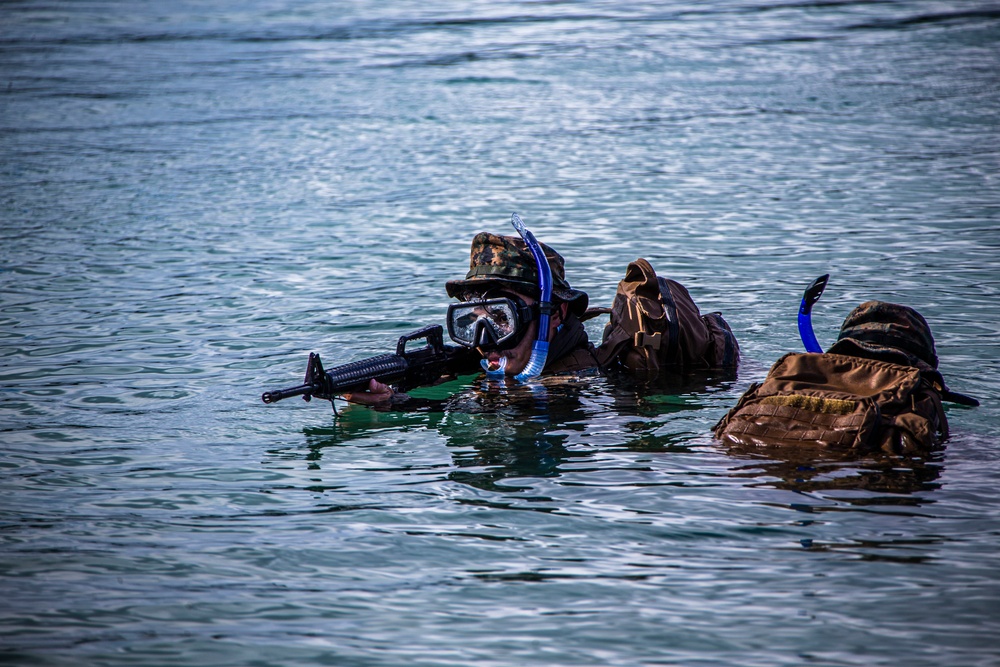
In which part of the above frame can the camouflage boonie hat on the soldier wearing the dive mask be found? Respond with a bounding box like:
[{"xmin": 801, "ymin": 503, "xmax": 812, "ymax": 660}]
[{"xmin": 445, "ymin": 232, "xmax": 589, "ymax": 315}]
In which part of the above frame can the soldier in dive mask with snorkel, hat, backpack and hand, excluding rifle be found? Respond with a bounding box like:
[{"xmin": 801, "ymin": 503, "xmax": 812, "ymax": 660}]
[{"xmin": 343, "ymin": 214, "xmax": 739, "ymax": 409}]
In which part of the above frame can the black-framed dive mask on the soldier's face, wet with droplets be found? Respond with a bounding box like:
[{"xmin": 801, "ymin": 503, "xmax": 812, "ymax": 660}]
[{"xmin": 448, "ymin": 295, "xmax": 537, "ymax": 350}]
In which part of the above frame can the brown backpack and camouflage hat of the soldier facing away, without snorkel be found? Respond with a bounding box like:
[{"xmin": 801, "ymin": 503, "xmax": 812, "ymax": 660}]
[{"xmin": 715, "ymin": 301, "xmax": 979, "ymax": 454}]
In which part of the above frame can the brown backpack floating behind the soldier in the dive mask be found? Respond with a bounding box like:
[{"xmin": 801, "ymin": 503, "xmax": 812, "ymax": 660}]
[{"xmin": 596, "ymin": 259, "xmax": 740, "ymax": 380}]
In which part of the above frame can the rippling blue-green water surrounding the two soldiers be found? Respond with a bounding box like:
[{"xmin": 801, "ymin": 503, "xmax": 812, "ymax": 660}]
[{"xmin": 0, "ymin": 0, "xmax": 1000, "ymax": 666}]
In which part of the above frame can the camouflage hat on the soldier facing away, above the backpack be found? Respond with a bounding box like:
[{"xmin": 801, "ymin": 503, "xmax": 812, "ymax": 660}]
[{"xmin": 829, "ymin": 301, "xmax": 938, "ymax": 369}]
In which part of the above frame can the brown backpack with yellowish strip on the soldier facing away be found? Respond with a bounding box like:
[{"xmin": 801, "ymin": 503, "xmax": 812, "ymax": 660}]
[{"xmin": 715, "ymin": 353, "xmax": 948, "ymax": 454}]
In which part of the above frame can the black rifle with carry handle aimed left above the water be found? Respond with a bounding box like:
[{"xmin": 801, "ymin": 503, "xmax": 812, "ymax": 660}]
[{"xmin": 261, "ymin": 324, "xmax": 479, "ymax": 403}]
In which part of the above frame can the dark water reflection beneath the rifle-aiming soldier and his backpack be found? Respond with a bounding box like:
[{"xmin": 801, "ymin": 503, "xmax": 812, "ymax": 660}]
[{"xmin": 296, "ymin": 374, "xmax": 735, "ymax": 492}]
